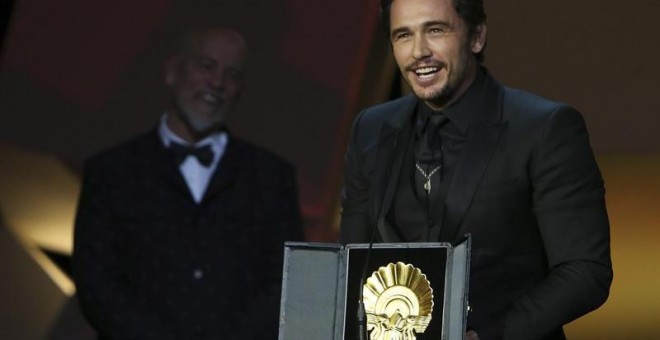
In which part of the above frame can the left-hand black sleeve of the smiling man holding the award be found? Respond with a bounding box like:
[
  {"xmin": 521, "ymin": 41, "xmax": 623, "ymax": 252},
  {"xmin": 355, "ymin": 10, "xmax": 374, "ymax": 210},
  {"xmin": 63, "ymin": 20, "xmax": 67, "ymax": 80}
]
[{"xmin": 339, "ymin": 111, "xmax": 371, "ymax": 244}]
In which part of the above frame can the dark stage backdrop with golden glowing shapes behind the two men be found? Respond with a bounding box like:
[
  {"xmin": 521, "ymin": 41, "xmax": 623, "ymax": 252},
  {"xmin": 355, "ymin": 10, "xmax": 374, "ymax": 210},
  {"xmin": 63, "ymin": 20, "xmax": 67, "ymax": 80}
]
[{"xmin": 0, "ymin": 0, "xmax": 660, "ymax": 339}]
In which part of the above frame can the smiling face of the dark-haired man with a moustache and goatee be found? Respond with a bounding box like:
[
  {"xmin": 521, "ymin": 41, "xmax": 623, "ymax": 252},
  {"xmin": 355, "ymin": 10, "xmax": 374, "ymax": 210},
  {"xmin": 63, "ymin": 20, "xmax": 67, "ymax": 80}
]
[{"xmin": 390, "ymin": 0, "xmax": 486, "ymax": 109}]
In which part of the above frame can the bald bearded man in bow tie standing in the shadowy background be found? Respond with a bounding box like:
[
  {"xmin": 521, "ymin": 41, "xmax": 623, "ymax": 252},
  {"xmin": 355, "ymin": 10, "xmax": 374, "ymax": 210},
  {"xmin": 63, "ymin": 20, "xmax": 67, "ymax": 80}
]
[{"xmin": 73, "ymin": 29, "xmax": 302, "ymax": 339}]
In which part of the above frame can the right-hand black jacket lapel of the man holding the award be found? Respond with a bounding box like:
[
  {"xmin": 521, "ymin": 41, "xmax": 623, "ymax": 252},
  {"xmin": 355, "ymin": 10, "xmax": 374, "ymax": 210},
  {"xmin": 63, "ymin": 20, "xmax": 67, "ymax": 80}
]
[{"xmin": 436, "ymin": 75, "xmax": 506, "ymax": 242}]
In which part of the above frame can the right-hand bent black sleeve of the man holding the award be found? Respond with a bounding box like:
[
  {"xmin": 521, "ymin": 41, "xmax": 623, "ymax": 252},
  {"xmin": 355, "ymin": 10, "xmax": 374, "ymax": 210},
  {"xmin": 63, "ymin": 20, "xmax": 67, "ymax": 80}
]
[{"xmin": 504, "ymin": 107, "xmax": 612, "ymax": 339}]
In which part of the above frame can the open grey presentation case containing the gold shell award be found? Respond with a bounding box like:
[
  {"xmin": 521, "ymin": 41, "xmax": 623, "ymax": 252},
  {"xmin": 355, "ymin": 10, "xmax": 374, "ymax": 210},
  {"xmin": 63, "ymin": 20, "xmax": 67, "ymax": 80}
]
[{"xmin": 279, "ymin": 236, "xmax": 470, "ymax": 340}]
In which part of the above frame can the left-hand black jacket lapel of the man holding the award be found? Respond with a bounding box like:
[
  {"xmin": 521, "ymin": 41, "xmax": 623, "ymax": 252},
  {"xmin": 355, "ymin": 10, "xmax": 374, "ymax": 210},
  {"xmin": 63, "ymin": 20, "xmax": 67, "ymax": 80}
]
[{"xmin": 373, "ymin": 96, "xmax": 417, "ymax": 242}]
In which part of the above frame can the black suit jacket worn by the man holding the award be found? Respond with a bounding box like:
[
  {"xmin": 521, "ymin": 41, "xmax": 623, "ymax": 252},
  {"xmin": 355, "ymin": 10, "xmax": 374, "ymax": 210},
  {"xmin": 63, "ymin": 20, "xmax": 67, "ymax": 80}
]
[{"xmin": 340, "ymin": 76, "xmax": 612, "ymax": 340}]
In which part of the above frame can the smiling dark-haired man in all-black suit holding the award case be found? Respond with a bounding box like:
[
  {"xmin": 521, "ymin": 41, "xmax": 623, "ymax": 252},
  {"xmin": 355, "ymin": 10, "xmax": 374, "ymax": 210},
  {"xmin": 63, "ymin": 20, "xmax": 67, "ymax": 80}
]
[{"xmin": 340, "ymin": 0, "xmax": 612, "ymax": 339}]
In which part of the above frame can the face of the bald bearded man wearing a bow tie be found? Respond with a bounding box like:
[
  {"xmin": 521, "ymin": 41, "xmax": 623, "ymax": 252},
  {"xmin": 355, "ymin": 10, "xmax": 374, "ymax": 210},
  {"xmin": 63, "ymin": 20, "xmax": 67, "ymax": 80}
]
[{"xmin": 165, "ymin": 30, "xmax": 245, "ymax": 135}]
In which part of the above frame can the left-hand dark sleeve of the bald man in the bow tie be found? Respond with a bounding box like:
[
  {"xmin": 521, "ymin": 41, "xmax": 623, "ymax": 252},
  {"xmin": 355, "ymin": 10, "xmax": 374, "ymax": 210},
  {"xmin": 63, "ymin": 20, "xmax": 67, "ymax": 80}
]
[{"xmin": 72, "ymin": 163, "xmax": 175, "ymax": 339}]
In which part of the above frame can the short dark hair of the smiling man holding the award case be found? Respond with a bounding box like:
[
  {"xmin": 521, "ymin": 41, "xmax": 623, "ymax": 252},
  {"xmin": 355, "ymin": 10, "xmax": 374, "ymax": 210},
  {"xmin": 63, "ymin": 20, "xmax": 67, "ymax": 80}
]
[{"xmin": 380, "ymin": 0, "xmax": 486, "ymax": 63}]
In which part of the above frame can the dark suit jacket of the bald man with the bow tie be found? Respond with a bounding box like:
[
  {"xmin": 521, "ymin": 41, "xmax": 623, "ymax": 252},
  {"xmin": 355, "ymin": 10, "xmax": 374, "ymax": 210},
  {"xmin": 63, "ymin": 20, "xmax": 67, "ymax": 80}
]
[{"xmin": 73, "ymin": 131, "xmax": 302, "ymax": 339}]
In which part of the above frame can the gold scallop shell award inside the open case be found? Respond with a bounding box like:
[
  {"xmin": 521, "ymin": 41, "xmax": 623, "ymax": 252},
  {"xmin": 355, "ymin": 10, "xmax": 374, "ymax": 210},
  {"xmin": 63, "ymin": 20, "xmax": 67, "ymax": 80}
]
[{"xmin": 362, "ymin": 262, "xmax": 433, "ymax": 340}]
